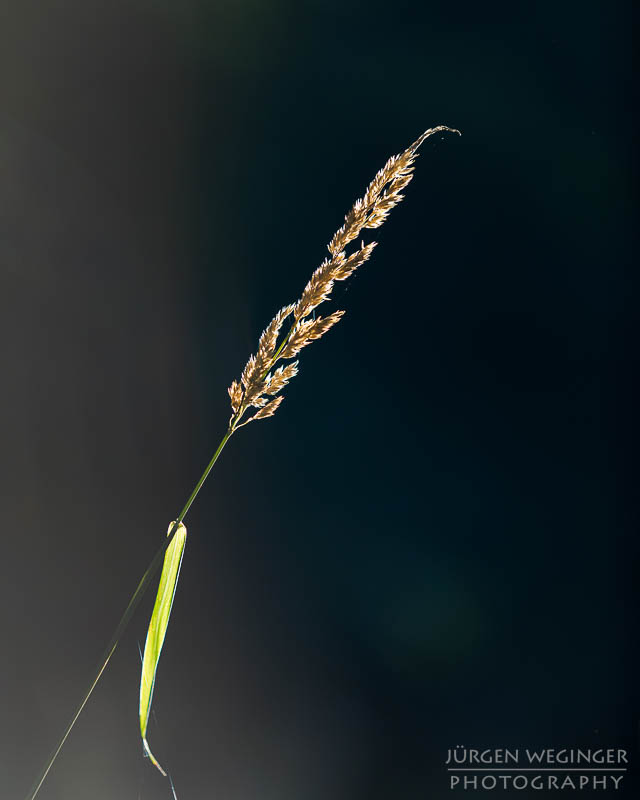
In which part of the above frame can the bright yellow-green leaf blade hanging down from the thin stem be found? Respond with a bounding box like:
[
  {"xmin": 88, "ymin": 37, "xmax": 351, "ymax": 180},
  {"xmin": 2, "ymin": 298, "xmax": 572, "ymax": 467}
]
[{"xmin": 140, "ymin": 522, "xmax": 187, "ymax": 775}]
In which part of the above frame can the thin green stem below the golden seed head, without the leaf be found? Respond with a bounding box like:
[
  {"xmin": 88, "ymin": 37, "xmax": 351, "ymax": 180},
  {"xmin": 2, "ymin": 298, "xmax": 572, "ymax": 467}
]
[{"xmin": 26, "ymin": 421, "xmax": 235, "ymax": 800}]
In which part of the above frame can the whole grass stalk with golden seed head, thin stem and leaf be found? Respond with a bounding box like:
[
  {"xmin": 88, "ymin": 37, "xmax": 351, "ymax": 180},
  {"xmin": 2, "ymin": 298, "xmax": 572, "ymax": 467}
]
[{"xmin": 26, "ymin": 125, "xmax": 459, "ymax": 800}]
